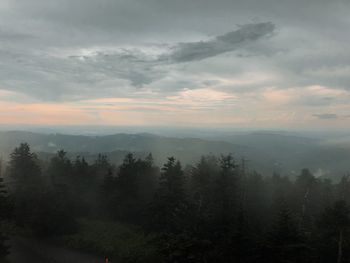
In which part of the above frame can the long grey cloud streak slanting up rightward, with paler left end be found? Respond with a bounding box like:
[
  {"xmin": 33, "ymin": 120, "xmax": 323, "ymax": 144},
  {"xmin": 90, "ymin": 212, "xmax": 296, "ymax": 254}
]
[{"xmin": 62, "ymin": 22, "xmax": 275, "ymax": 91}]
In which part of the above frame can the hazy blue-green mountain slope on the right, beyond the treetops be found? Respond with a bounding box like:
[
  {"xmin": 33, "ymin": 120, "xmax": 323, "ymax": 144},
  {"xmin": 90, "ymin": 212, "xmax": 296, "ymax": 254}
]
[{"xmin": 222, "ymin": 132, "xmax": 350, "ymax": 177}]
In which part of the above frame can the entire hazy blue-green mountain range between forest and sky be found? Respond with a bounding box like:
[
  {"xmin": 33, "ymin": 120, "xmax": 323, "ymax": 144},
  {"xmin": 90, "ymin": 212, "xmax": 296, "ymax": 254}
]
[{"xmin": 0, "ymin": 131, "xmax": 350, "ymax": 177}]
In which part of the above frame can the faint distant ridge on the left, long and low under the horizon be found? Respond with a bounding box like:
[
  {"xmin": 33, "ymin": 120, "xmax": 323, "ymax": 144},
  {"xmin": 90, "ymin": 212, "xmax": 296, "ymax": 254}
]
[{"xmin": 0, "ymin": 131, "xmax": 243, "ymax": 153}]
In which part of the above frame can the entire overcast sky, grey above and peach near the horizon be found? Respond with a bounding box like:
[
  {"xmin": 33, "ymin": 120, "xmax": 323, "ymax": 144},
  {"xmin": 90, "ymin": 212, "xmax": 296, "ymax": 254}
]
[{"xmin": 0, "ymin": 0, "xmax": 350, "ymax": 129}]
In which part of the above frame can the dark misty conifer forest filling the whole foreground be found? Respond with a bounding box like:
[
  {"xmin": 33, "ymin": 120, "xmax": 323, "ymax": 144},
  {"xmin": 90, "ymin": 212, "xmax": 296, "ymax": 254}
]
[{"xmin": 0, "ymin": 143, "xmax": 350, "ymax": 263}]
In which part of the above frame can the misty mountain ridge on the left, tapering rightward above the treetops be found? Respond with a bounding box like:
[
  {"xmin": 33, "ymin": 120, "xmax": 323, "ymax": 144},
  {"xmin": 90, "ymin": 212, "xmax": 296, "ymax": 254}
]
[{"xmin": 0, "ymin": 131, "xmax": 244, "ymax": 166}]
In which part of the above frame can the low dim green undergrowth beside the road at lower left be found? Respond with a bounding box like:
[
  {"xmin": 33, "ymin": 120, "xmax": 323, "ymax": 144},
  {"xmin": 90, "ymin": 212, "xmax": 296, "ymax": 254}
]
[{"xmin": 64, "ymin": 219, "xmax": 161, "ymax": 263}]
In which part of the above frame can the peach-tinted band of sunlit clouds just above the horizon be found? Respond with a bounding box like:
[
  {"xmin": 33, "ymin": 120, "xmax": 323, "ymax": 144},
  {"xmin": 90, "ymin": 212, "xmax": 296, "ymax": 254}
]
[{"xmin": 0, "ymin": 86, "xmax": 350, "ymax": 127}]
